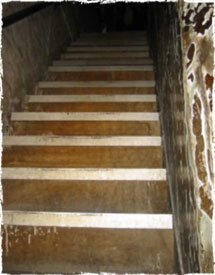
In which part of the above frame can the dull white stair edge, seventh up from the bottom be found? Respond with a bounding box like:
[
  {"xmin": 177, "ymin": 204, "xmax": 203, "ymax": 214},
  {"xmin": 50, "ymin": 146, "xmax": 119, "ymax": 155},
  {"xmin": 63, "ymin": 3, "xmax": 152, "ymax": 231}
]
[{"xmin": 48, "ymin": 65, "xmax": 154, "ymax": 72}]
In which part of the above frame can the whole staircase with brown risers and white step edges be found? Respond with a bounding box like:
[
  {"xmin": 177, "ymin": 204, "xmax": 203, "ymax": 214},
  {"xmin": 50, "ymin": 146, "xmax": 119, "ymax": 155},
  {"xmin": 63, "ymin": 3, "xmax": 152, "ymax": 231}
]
[{"xmin": 2, "ymin": 32, "xmax": 175, "ymax": 274}]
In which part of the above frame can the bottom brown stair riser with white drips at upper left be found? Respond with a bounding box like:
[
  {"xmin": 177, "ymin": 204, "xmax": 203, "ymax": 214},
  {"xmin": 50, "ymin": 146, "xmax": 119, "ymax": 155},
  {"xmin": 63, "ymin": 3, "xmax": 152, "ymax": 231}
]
[{"xmin": 2, "ymin": 226, "xmax": 174, "ymax": 274}]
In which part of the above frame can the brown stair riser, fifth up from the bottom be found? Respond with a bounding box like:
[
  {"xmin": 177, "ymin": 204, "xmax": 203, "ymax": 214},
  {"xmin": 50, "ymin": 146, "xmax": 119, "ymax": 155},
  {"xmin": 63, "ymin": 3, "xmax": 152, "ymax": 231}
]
[{"xmin": 26, "ymin": 102, "xmax": 157, "ymax": 112}]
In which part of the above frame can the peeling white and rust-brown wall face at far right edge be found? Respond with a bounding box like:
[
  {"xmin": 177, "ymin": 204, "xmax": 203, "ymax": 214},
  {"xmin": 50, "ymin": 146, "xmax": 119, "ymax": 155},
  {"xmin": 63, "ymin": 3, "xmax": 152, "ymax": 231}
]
[{"xmin": 180, "ymin": 3, "xmax": 214, "ymax": 271}]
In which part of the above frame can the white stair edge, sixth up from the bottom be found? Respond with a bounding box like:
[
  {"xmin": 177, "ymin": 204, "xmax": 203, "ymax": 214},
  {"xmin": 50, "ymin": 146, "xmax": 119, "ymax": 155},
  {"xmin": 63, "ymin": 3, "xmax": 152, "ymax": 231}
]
[{"xmin": 38, "ymin": 80, "xmax": 155, "ymax": 88}]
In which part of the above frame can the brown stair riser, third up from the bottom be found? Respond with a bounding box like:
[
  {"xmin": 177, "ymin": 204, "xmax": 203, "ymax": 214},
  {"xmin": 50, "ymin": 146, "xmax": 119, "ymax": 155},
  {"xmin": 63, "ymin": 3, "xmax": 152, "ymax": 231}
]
[{"xmin": 2, "ymin": 146, "xmax": 162, "ymax": 168}]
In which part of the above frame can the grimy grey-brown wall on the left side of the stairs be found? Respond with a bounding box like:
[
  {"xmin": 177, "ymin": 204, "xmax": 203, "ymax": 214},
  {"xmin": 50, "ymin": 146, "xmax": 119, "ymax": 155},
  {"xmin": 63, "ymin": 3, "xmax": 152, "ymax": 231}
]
[{"xmin": 2, "ymin": 3, "xmax": 77, "ymax": 133}]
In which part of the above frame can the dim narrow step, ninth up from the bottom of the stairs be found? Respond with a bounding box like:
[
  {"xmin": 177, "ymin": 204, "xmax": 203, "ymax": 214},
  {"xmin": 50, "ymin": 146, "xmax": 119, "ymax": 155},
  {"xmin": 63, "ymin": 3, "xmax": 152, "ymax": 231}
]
[{"xmin": 61, "ymin": 51, "xmax": 149, "ymax": 59}]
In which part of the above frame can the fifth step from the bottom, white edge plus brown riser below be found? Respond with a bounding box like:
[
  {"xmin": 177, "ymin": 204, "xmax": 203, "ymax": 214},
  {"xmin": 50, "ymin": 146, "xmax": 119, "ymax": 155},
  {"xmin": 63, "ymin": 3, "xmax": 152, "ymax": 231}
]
[{"xmin": 26, "ymin": 94, "xmax": 157, "ymax": 112}]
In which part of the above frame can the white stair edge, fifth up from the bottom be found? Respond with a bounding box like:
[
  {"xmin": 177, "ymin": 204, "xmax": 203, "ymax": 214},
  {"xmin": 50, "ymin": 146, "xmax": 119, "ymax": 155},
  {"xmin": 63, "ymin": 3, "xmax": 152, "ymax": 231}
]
[{"xmin": 26, "ymin": 94, "xmax": 156, "ymax": 103}]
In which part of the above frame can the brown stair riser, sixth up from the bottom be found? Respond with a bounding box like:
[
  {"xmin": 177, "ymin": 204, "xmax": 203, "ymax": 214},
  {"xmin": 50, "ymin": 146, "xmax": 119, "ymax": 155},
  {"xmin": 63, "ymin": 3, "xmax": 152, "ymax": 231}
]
[{"xmin": 37, "ymin": 87, "xmax": 155, "ymax": 95}]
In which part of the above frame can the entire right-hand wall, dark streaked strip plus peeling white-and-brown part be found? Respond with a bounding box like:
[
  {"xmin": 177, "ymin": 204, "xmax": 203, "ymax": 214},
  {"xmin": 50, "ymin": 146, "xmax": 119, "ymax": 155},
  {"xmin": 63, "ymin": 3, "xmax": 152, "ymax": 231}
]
[{"xmin": 150, "ymin": 3, "xmax": 214, "ymax": 273}]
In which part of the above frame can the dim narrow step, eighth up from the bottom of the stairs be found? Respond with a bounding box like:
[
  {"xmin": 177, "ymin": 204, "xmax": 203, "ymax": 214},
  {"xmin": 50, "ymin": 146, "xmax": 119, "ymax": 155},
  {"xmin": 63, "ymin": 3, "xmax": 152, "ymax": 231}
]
[{"xmin": 53, "ymin": 57, "xmax": 153, "ymax": 66}]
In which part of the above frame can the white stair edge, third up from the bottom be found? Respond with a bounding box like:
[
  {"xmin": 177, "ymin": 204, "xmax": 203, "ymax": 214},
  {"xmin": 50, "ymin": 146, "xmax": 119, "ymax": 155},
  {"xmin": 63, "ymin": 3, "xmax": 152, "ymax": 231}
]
[{"xmin": 3, "ymin": 136, "xmax": 161, "ymax": 146}]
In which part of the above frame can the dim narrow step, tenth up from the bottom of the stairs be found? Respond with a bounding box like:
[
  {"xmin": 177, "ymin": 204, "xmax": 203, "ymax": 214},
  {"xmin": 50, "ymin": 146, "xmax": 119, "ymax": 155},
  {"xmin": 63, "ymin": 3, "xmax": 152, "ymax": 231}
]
[{"xmin": 67, "ymin": 45, "xmax": 149, "ymax": 52}]
